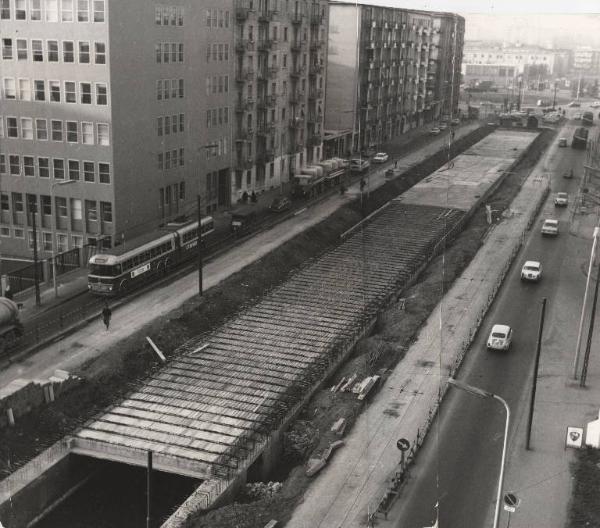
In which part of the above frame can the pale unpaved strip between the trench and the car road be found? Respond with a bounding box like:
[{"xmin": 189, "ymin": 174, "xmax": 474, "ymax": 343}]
[{"xmin": 286, "ymin": 144, "xmax": 547, "ymax": 528}]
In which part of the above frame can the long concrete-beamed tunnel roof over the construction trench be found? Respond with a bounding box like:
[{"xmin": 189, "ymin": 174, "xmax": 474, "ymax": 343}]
[{"xmin": 0, "ymin": 131, "xmax": 536, "ymax": 527}]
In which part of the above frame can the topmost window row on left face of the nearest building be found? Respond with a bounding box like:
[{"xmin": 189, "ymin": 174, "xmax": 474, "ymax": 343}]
[{"xmin": 0, "ymin": 0, "xmax": 106, "ymax": 22}]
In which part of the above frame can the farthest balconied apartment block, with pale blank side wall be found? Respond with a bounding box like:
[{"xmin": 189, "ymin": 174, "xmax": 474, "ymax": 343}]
[{"xmin": 325, "ymin": 2, "xmax": 464, "ymax": 155}]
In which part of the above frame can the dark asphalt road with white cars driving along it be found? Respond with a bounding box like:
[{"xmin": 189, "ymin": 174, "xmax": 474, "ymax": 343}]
[{"xmin": 394, "ymin": 120, "xmax": 585, "ymax": 528}]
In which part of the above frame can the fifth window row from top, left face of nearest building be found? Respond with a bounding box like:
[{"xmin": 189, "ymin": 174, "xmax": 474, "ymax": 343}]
[{"xmin": 0, "ymin": 154, "xmax": 111, "ymax": 184}]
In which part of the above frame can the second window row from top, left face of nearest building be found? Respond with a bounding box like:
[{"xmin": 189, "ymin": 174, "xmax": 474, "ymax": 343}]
[{"xmin": 2, "ymin": 38, "xmax": 106, "ymax": 64}]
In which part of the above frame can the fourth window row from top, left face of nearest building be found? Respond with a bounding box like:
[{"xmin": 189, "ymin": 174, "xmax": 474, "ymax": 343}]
[{"xmin": 0, "ymin": 117, "xmax": 110, "ymax": 146}]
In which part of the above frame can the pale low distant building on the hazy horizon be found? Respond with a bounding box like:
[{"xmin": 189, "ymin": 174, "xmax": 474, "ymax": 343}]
[{"xmin": 462, "ymin": 41, "xmax": 564, "ymax": 88}]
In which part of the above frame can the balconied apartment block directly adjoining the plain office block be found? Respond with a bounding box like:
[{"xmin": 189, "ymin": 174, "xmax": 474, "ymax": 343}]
[{"xmin": 232, "ymin": 0, "xmax": 328, "ymax": 199}]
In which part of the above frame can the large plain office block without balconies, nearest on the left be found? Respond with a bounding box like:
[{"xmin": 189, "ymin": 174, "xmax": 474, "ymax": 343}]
[{"xmin": 0, "ymin": 0, "xmax": 234, "ymax": 258}]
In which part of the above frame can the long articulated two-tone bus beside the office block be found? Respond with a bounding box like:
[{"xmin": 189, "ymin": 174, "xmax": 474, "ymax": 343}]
[{"xmin": 88, "ymin": 216, "xmax": 215, "ymax": 297}]
